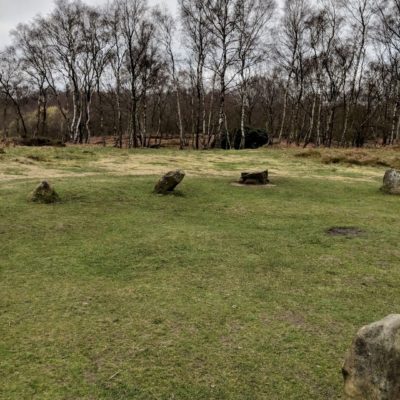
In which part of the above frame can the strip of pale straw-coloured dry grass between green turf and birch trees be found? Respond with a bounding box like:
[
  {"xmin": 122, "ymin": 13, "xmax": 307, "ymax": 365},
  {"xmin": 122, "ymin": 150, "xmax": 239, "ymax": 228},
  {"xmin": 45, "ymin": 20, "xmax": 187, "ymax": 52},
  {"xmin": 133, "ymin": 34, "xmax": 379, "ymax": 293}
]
[{"xmin": 0, "ymin": 146, "xmax": 400, "ymax": 186}]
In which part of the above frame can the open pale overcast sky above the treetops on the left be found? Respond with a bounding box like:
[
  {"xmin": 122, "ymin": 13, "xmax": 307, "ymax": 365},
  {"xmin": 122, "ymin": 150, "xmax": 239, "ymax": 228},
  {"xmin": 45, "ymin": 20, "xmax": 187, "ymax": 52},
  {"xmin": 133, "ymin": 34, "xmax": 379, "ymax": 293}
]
[{"xmin": 0, "ymin": 0, "xmax": 177, "ymax": 47}]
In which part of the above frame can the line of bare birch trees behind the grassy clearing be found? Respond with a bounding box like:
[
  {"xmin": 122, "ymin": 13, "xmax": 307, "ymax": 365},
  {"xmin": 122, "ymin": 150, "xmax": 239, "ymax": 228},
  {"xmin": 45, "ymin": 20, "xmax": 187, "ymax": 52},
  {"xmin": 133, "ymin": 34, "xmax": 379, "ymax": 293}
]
[{"xmin": 0, "ymin": 0, "xmax": 400, "ymax": 149}]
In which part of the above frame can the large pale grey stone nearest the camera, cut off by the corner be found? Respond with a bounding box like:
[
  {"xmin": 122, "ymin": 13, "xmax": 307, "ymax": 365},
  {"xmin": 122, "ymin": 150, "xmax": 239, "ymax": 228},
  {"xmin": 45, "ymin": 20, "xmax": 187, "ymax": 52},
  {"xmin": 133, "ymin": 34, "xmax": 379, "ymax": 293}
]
[{"xmin": 342, "ymin": 314, "xmax": 400, "ymax": 400}]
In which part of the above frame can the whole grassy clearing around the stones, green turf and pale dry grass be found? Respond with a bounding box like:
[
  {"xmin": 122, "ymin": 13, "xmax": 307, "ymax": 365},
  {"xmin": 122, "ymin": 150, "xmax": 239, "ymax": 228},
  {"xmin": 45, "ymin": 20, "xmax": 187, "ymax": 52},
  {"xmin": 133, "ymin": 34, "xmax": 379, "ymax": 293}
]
[{"xmin": 0, "ymin": 147, "xmax": 400, "ymax": 400}]
